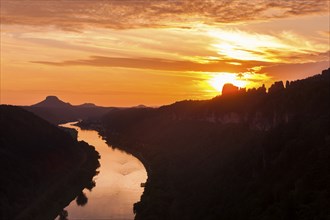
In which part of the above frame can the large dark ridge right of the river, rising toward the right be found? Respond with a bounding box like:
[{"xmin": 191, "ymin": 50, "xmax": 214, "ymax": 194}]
[{"xmin": 81, "ymin": 69, "xmax": 330, "ymax": 220}]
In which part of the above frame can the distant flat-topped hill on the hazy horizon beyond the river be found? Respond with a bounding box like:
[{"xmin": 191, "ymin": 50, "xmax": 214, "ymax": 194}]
[{"xmin": 23, "ymin": 96, "xmax": 115, "ymax": 124}]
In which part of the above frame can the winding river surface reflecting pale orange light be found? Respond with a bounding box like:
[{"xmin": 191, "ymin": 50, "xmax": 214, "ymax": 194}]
[{"xmin": 61, "ymin": 123, "xmax": 147, "ymax": 220}]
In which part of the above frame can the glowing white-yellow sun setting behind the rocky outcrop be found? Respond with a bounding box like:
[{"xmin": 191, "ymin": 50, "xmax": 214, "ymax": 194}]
[{"xmin": 208, "ymin": 73, "xmax": 248, "ymax": 92}]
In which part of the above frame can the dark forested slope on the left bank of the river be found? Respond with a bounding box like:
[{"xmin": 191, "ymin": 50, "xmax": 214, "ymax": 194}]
[{"xmin": 0, "ymin": 105, "xmax": 99, "ymax": 220}]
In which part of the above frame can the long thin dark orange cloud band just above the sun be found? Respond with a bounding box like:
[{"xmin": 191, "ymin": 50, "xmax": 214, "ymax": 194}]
[{"xmin": 31, "ymin": 56, "xmax": 329, "ymax": 82}]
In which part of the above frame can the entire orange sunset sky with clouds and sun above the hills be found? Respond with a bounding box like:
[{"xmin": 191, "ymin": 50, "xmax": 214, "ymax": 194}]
[{"xmin": 1, "ymin": 0, "xmax": 330, "ymax": 106}]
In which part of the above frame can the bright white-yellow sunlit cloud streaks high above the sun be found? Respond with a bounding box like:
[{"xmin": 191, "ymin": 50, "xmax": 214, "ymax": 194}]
[{"xmin": 209, "ymin": 29, "xmax": 329, "ymax": 63}]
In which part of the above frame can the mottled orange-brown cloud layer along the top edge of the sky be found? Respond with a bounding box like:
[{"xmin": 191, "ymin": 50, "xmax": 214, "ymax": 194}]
[{"xmin": 1, "ymin": 0, "xmax": 329, "ymax": 30}]
